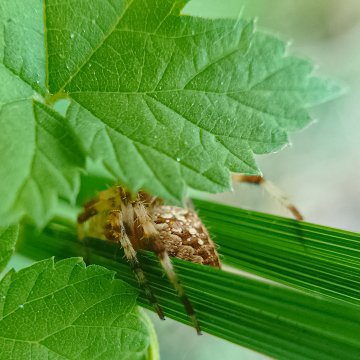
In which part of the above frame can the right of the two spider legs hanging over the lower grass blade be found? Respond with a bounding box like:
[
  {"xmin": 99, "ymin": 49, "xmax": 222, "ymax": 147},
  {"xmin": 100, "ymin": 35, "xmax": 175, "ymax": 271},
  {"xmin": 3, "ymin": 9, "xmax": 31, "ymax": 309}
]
[{"xmin": 134, "ymin": 202, "xmax": 202, "ymax": 335}]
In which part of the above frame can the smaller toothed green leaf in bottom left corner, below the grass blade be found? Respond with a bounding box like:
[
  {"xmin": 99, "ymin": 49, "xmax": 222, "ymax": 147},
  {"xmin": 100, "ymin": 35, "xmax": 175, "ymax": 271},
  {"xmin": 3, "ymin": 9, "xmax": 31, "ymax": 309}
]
[{"xmin": 0, "ymin": 258, "xmax": 158, "ymax": 360}]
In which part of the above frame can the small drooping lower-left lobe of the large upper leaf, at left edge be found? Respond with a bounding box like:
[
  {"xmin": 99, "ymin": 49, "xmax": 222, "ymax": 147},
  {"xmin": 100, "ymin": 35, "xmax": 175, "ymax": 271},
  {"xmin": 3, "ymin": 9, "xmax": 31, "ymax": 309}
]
[{"xmin": 0, "ymin": 87, "xmax": 84, "ymax": 226}]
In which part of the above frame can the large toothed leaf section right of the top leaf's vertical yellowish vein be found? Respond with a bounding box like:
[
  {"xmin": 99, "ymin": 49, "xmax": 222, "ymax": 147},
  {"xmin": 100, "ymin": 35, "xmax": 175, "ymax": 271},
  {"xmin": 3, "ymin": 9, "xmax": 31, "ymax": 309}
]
[{"xmin": 45, "ymin": 0, "xmax": 339, "ymax": 201}]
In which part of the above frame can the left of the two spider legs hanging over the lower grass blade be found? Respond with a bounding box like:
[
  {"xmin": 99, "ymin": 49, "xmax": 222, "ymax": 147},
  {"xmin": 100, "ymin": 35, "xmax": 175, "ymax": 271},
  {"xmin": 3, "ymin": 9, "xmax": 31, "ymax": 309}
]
[{"xmin": 105, "ymin": 210, "xmax": 165, "ymax": 320}]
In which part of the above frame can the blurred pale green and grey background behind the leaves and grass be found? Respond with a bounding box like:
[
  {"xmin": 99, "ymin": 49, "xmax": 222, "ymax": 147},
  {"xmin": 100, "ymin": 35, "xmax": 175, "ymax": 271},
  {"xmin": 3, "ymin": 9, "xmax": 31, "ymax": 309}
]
[{"xmin": 3, "ymin": 0, "xmax": 360, "ymax": 360}]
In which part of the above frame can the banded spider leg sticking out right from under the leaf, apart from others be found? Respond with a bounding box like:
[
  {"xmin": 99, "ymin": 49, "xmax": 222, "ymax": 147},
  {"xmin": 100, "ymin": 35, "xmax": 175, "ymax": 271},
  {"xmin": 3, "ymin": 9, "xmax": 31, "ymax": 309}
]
[{"xmin": 232, "ymin": 174, "xmax": 304, "ymax": 220}]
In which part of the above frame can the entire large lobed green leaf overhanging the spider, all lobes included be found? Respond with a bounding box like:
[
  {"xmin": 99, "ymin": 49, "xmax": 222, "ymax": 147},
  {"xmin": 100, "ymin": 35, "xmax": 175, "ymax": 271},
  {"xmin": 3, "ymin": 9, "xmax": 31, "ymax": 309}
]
[{"xmin": 0, "ymin": 0, "xmax": 338, "ymax": 226}]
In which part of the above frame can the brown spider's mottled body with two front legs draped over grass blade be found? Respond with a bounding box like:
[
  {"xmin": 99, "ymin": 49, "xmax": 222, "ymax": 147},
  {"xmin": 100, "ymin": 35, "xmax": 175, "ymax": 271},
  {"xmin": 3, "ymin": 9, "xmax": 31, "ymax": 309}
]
[{"xmin": 78, "ymin": 186, "xmax": 221, "ymax": 334}]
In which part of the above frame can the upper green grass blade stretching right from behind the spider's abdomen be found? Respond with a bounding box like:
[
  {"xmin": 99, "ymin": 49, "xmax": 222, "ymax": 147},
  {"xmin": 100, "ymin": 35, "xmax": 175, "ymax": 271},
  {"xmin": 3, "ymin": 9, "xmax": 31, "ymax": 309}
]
[{"xmin": 194, "ymin": 200, "xmax": 360, "ymax": 305}]
